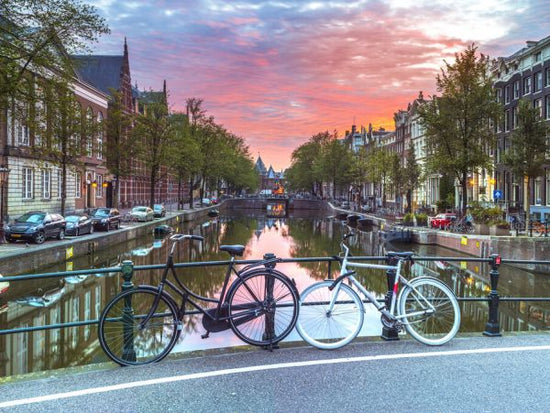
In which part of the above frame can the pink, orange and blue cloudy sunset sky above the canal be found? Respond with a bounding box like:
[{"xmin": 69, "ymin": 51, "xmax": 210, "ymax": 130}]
[{"xmin": 88, "ymin": 0, "xmax": 550, "ymax": 171}]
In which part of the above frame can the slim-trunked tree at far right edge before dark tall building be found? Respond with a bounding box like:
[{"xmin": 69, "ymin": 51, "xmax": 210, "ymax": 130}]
[{"xmin": 503, "ymin": 99, "xmax": 550, "ymax": 228}]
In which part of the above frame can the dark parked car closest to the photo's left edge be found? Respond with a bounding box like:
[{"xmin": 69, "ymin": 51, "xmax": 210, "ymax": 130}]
[{"xmin": 4, "ymin": 211, "xmax": 65, "ymax": 244}]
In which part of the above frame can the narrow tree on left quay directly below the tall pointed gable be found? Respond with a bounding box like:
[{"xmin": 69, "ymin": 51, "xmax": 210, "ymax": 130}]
[{"xmin": 105, "ymin": 90, "xmax": 137, "ymax": 207}]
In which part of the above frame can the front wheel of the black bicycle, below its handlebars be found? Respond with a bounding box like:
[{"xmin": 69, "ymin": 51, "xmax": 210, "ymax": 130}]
[{"xmin": 98, "ymin": 287, "xmax": 181, "ymax": 366}]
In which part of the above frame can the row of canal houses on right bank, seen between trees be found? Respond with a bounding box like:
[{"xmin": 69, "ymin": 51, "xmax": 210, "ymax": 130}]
[{"xmin": 342, "ymin": 36, "xmax": 550, "ymax": 212}]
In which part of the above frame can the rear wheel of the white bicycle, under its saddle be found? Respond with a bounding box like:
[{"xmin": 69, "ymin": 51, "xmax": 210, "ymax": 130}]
[{"xmin": 397, "ymin": 277, "xmax": 460, "ymax": 346}]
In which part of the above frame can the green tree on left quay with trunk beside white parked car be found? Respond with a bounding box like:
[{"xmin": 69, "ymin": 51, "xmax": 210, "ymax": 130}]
[{"xmin": 132, "ymin": 91, "xmax": 175, "ymax": 208}]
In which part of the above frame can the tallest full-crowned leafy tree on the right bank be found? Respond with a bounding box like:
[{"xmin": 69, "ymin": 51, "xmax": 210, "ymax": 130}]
[{"xmin": 418, "ymin": 45, "xmax": 500, "ymax": 213}]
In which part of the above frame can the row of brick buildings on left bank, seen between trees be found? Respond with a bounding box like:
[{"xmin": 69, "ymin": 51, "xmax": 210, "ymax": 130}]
[{"xmin": 0, "ymin": 40, "xmax": 181, "ymax": 222}]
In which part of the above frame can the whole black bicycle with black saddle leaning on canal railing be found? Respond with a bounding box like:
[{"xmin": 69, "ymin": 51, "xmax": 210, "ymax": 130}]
[{"xmin": 98, "ymin": 234, "xmax": 299, "ymax": 366}]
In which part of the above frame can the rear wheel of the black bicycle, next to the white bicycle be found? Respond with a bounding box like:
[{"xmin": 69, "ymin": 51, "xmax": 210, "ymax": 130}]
[{"xmin": 227, "ymin": 271, "xmax": 299, "ymax": 346}]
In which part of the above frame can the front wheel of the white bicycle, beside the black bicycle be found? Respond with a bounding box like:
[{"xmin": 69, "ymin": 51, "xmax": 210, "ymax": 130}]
[{"xmin": 296, "ymin": 281, "xmax": 364, "ymax": 350}]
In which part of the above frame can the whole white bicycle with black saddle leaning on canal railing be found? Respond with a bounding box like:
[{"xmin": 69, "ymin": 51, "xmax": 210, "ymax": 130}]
[{"xmin": 296, "ymin": 233, "xmax": 460, "ymax": 350}]
